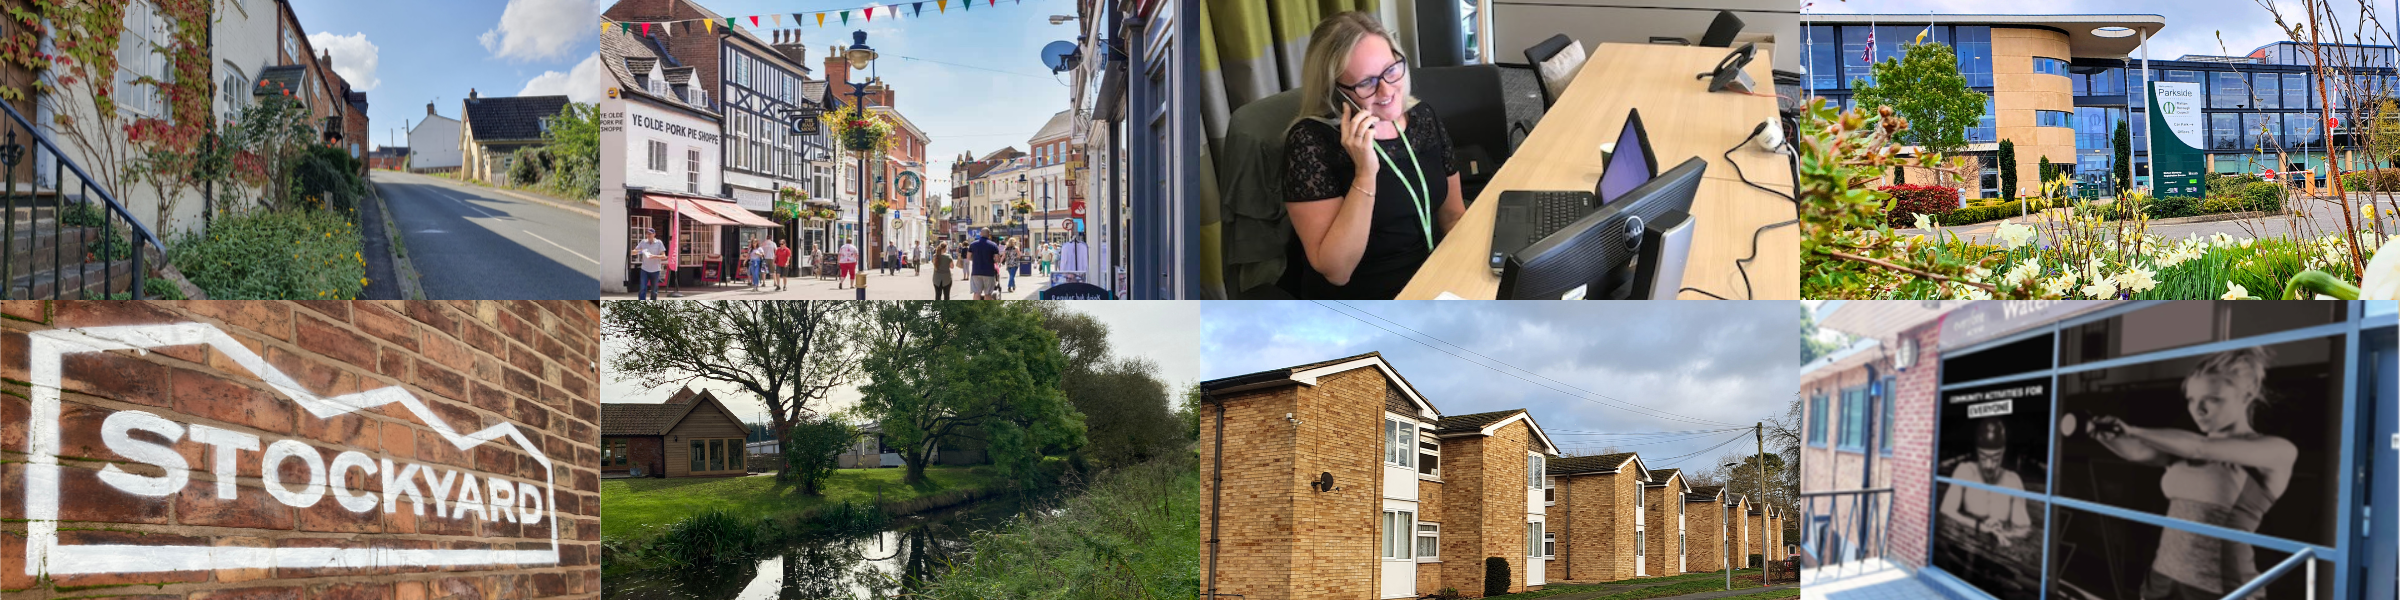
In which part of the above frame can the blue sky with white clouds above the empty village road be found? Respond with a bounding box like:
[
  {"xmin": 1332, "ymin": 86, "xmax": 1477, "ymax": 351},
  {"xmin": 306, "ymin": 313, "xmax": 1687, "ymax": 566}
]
[{"xmin": 293, "ymin": 0, "xmax": 605, "ymax": 146}]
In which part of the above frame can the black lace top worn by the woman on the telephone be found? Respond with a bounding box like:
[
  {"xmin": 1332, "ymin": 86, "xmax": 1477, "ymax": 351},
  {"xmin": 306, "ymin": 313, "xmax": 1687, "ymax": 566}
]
[{"xmin": 1284, "ymin": 103, "xmax": 1457, "ymax": 300}]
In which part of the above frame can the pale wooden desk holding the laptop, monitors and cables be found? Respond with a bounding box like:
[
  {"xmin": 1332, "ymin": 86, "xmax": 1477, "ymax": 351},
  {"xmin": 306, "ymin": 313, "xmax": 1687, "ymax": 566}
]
[{"xmin": 1399, "ymin": 43, "xmax": 1800, "ymax": 300}]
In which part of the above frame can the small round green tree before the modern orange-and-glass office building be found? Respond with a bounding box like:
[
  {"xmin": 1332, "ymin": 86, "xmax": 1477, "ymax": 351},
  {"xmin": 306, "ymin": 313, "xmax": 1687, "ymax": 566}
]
[{"xmin": 1850, "ymin": 43, "xmax": 1985, "ymax": 185}]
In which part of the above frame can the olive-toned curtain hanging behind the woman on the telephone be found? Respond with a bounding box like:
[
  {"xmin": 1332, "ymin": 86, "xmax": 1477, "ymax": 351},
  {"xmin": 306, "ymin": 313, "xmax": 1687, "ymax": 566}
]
[{"xmin": 1200, "ymin": 0, "xmax": 1399, "ymax": 298}]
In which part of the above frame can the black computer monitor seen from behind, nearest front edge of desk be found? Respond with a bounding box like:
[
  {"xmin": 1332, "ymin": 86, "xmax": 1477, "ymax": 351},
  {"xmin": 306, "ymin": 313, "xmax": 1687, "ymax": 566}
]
[{"xmin": 1498, "ymin": 156, "xmax": 1709, "ymax": 300}]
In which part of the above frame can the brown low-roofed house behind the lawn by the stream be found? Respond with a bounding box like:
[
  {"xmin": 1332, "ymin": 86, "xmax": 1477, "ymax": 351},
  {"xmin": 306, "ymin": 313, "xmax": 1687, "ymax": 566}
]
[{"xmin": 600, "ymin": 386, "xmax": 749, "ymax": 478}]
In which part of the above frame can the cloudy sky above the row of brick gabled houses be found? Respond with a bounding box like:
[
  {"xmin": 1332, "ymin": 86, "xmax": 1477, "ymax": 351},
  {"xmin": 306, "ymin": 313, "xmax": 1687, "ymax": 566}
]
[{"xmin": 1200, "ymin": 302, "xmax": 1800, "ymax": 470}]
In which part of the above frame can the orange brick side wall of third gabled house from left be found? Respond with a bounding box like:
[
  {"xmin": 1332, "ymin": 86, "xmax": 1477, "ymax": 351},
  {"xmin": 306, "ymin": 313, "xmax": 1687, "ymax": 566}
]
[{"xmin": 1553, "ymin": 473, "xmax": 1639, "ymax": 581}]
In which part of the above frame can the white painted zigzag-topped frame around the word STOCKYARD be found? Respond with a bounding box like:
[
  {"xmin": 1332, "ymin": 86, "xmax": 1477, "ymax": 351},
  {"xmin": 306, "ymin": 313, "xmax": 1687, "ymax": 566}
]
[{"xmin": 24, "ymin": 324, "xmax": 559, "ymax": 576}]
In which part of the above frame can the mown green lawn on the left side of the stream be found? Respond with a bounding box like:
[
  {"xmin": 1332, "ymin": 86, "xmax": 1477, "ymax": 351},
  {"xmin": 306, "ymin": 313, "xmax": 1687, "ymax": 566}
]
[{"xmin": 600, "ymin": 466, "xmax": 1001, "ymax": 538}]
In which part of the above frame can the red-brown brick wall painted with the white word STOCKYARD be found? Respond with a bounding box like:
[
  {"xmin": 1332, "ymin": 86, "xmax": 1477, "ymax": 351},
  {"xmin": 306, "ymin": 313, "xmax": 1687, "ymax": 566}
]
[{"xmin": 0, "ymin": 300, "xmax": 600, "ymax": 600}]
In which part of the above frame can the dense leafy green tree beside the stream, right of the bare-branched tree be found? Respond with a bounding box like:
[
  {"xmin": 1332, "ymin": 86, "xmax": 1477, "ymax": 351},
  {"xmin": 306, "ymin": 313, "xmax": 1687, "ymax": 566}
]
[{"xmin": 854, "ymin": 300, "xmax": 1085, "ymax": 485}]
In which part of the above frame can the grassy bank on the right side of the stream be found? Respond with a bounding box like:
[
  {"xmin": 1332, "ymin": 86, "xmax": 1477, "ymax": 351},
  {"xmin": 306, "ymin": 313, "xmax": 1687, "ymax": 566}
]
[{"xmin": 917, "ymin": 454, "xmax": 1200, "ymax": 600}]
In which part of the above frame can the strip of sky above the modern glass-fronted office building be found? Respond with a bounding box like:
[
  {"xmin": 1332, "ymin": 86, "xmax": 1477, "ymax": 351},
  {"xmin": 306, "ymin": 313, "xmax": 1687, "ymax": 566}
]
[{"xmin": 1805, "ymin": 0, "xmax": 2400, "ymax": 60}]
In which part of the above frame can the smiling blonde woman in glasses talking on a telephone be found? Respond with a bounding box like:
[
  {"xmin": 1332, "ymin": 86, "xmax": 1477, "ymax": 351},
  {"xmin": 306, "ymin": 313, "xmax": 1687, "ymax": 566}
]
[{"xmin": 1284, "ymin": 12, "xmax": 1466, "ymax": 300}]
